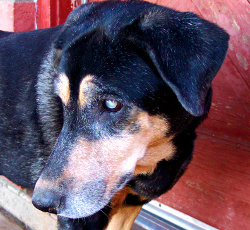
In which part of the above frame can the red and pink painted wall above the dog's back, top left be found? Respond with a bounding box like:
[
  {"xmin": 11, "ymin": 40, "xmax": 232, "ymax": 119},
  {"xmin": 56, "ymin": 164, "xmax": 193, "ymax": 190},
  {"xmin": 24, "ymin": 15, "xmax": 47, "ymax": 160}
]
[{"xmin": 0, "ymin": 0, "xmax": 81, "ymax": 32}]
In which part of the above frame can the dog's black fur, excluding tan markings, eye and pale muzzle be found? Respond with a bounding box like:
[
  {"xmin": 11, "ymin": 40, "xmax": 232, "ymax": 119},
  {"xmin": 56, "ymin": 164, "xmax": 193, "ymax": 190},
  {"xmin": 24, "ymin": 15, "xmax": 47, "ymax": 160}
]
[{"xmin": 0, "ymin": 1, "xmax": 229, "ymax": 229}]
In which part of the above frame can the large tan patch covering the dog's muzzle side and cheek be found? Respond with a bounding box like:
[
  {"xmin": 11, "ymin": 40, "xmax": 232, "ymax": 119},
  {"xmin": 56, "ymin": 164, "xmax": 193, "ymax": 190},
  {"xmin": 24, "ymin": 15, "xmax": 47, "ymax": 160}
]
[{"xmin": 57, "ymin": 111, "xmax": 171, "ymax": 193}]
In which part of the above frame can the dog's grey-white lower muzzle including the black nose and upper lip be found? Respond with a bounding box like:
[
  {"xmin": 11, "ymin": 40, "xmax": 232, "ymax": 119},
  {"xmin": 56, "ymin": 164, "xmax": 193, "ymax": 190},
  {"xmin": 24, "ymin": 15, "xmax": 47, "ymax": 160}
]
[{"xmin": 32, "ymin": 174, "xmax": 131, "ymax": 219}]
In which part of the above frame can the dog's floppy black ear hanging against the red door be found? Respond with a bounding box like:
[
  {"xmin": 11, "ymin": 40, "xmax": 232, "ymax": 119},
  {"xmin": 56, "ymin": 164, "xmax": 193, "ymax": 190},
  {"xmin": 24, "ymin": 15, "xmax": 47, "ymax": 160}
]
[{"xmin": 126, "ymin": 6, "xmax": 229, "ymax": 116}]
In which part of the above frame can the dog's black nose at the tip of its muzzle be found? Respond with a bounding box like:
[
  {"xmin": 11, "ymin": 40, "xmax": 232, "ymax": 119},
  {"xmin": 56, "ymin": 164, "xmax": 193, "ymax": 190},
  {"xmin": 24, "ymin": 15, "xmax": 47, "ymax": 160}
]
[{"xmin": 32, "ymin": 190, "xmax": 60, "ymax": 213}]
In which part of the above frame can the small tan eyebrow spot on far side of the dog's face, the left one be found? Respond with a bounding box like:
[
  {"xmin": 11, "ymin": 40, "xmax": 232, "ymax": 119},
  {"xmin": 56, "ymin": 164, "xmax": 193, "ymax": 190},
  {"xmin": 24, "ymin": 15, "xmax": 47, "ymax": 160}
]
[{"xmin": 57, "ymin": 73, "xmax": 70, "ymax": 105}]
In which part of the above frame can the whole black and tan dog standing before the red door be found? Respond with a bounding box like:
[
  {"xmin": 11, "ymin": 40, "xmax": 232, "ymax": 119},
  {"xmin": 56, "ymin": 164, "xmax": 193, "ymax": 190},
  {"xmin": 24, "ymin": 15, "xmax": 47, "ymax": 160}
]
[{"xmin": 0, "ymin": 1, "xmax": 229, "ymax": 230}]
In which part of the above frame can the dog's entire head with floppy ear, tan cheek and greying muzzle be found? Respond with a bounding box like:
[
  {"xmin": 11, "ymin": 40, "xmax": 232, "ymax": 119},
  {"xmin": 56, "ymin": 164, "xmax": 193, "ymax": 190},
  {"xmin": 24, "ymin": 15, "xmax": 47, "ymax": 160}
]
[{"xmin": 33, "ymin": 1, "xmax": 228, "ymax": 218}]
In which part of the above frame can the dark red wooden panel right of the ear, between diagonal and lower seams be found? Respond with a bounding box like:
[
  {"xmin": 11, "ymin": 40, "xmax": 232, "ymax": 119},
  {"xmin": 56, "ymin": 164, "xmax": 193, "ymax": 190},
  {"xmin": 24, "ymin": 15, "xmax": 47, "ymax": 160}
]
[{"xmin": 199, "ymin": 57, "xmax": 250, "ymax": 145}]
